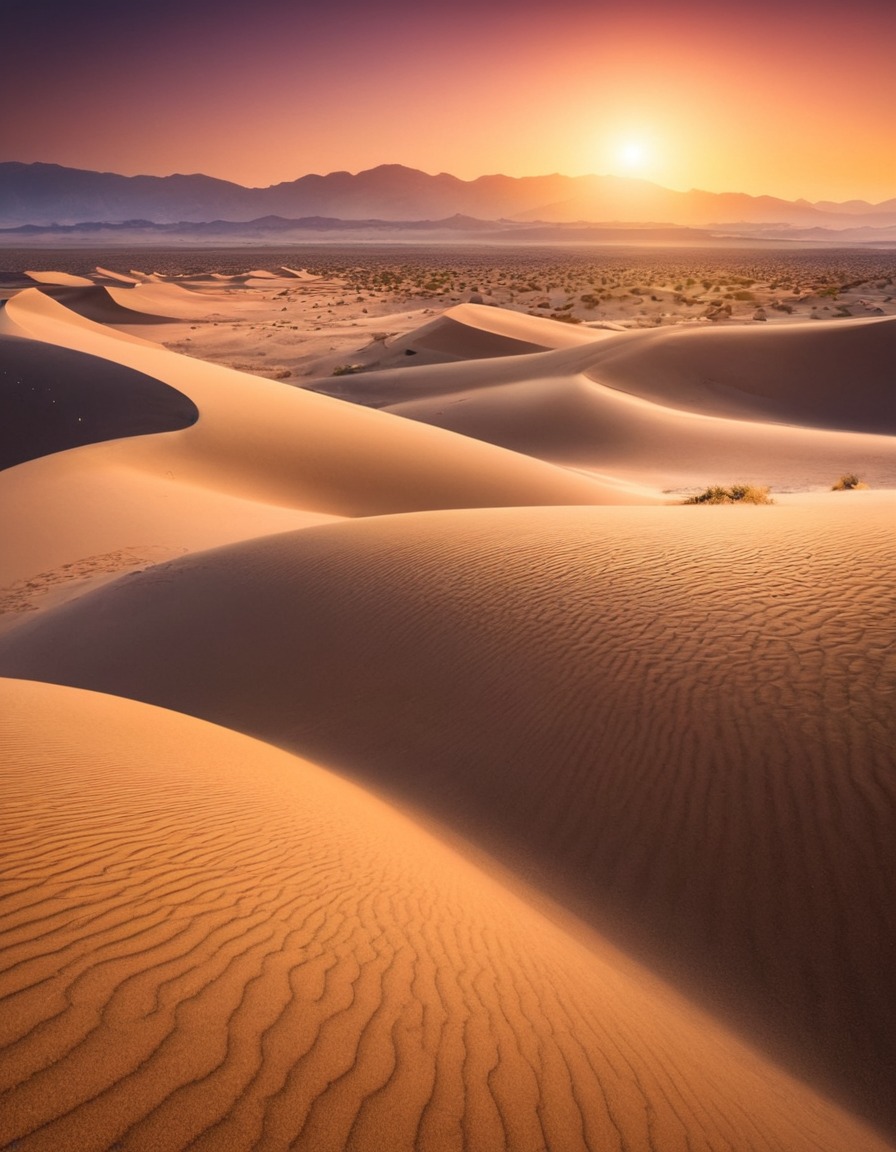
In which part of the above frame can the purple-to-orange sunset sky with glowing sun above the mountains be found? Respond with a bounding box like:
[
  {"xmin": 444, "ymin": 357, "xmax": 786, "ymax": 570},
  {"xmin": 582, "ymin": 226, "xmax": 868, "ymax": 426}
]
[{"xmin": 0, "ymin": 0, "xmax": 896, "ymax": 202}]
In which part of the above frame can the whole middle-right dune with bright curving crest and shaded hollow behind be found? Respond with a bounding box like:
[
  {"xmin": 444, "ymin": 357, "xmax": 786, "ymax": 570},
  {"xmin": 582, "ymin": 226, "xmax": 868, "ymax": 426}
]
[{"xmin": 313, "ymin": 308, "xmax": 896, "ymax": 490}]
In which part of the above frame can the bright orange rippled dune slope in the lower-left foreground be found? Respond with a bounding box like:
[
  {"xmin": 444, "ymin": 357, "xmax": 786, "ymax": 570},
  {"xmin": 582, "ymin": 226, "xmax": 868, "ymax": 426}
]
[{"xmin": 0, "ymin": 681, "xmax": 887, "ymax": 1152}]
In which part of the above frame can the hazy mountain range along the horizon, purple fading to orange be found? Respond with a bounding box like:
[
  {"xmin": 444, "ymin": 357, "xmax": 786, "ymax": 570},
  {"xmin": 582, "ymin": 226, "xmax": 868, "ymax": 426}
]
[{"xmin": 0, "ymin": 161, "xmax": 896, "ymax": 232}]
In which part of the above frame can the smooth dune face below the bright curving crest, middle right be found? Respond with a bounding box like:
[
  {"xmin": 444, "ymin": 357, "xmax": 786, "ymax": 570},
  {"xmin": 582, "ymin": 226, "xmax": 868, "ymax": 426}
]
[{"xmin": 385, "ymin": 365, "xmax": 896, "ymax": 486}]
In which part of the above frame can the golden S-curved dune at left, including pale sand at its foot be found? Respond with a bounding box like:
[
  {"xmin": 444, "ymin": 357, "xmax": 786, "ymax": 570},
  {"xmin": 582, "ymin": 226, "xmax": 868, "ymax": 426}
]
[{"xmin": 0, "ymin": 291, "xmax": 626, "ymax": 627}]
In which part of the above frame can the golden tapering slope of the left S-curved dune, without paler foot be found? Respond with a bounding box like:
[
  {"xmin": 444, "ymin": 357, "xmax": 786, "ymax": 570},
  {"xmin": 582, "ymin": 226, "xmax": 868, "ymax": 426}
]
[{"xmin": 0, "ymin": 289, "xmax": 644, "ymax": 516}]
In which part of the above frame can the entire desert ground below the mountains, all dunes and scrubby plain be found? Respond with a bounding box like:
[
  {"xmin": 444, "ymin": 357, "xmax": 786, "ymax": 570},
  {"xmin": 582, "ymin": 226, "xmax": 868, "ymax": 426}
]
[{"xmin": 0, "ymin": 248, "xmax": 896, "ymax": 1152}]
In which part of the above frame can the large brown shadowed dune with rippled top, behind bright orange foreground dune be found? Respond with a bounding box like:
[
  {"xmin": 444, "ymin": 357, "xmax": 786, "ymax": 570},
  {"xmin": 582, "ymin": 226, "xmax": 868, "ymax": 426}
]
[{"xmin": 0, "ymin": 501, "xmax": 896, "ymax": 1122}]
